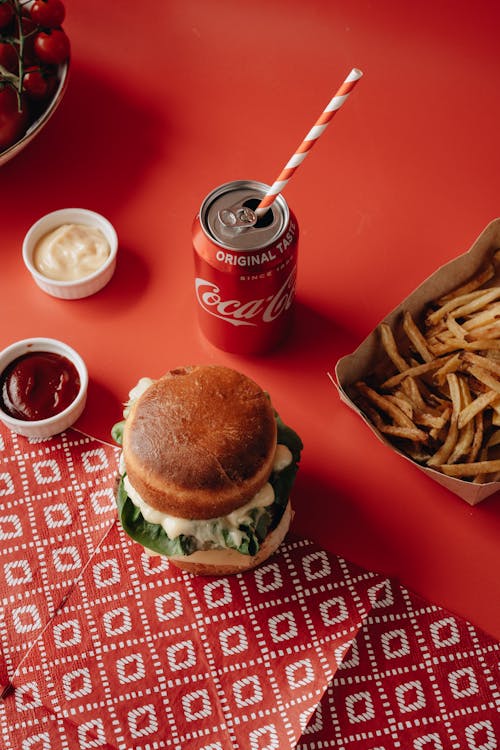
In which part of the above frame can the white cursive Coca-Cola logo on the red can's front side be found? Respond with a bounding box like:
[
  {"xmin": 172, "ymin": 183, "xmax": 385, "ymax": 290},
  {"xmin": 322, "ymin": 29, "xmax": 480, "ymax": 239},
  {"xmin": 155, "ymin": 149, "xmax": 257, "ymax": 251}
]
[{"xmin": 195, "ymin": 268, "xmax": 297, "ymax": 326}]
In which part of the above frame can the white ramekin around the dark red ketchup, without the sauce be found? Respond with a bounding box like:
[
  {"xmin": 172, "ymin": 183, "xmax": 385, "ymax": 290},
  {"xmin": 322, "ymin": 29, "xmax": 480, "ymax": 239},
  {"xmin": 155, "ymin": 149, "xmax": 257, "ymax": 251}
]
[{"xmin": 0, "ymin": 338, "xmax": 89, "ymax": 438}]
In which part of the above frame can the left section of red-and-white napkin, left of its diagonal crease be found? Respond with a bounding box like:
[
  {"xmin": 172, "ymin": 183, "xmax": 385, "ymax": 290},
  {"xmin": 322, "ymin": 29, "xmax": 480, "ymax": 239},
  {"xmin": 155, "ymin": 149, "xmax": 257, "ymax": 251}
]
[{"xmin": 0, "ymin": 425, "xmax": 118, "ymax": 700}]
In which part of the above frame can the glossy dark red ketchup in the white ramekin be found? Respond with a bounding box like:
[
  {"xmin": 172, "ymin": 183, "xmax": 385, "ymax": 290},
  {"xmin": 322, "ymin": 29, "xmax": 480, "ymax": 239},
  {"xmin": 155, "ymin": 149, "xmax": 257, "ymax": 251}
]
[{"xmin": 0, "ymin": 352, "xmax": 80, "ymax": 422}]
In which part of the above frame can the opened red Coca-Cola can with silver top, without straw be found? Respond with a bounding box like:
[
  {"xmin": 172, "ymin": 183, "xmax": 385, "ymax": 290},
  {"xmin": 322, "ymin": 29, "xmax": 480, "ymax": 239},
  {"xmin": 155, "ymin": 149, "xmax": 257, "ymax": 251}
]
[{"xmin": 193, "ymin": 180, "xmax": 299, "ymax": 354}]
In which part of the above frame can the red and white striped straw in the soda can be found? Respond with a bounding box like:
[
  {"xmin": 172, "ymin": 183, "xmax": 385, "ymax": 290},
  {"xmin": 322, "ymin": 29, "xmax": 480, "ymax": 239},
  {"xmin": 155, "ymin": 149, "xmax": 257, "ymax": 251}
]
[{"xmin": 255, "ymin": 68, "xmax": 363, "ymax": 216}]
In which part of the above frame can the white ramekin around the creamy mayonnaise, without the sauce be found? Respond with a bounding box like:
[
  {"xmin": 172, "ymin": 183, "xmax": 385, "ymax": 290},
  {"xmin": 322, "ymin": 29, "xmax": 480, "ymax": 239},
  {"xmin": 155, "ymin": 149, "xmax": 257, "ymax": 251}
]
[{"xmin": 23, "ymin": 208, "xmax": 118, "ymax": 299}]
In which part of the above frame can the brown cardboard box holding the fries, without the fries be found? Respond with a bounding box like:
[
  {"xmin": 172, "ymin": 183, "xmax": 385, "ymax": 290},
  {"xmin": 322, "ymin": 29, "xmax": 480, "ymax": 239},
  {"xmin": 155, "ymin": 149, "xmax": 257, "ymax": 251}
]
[{"xmin": 335, "ymin": 218, "xmax": 500, "ymax": 505}]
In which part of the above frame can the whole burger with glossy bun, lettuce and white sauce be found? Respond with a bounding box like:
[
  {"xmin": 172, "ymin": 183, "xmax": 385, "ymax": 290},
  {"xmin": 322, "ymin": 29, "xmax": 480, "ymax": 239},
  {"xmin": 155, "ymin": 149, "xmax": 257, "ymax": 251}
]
[{"xmin": 112, "ymin": 365, "xmax": 302, "ymax": 575}]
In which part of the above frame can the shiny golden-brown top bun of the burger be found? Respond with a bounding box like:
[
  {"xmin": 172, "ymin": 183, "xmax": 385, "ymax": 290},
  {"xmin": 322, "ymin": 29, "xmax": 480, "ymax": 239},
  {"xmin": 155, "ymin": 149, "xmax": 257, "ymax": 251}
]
[{"xmin": 123, "ymin": 365, "xmax": 277, "ymax": 520}]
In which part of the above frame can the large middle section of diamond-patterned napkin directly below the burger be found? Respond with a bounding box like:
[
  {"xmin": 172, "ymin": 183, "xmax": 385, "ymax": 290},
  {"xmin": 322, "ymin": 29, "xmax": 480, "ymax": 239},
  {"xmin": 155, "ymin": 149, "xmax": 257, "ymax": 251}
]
[{"xmin": 4, "ymin": 524, "xmax": 377, "ymax": 749}]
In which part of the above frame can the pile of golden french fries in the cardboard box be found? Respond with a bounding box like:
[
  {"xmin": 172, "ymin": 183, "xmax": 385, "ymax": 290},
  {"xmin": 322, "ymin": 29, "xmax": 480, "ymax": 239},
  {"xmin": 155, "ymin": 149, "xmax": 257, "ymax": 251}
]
[{"xmin": 353, "ymin": 252, "xmax": 500, "ymax": 484}]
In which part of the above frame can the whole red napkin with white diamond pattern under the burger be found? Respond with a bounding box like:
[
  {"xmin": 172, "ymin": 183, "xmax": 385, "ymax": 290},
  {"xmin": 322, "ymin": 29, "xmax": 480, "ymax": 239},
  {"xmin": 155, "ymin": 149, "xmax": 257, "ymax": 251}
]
[{"xmin": 0, "ymin": 427, "xmax": 500, "ymax": 750}]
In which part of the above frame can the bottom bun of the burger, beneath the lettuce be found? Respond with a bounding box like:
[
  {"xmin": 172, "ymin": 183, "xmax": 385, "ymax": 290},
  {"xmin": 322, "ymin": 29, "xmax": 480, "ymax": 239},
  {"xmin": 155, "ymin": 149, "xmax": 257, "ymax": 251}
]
[{"xmin": 145, "ymin": 501, "xmax": 293, "ymax": 576}]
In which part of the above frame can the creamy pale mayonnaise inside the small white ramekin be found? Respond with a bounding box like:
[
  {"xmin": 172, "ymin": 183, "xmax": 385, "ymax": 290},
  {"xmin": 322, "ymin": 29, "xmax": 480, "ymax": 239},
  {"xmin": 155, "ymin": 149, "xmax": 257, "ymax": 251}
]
[{"xmin": 33, "ymin": 224, "xmax": 110, "ymax": 281}]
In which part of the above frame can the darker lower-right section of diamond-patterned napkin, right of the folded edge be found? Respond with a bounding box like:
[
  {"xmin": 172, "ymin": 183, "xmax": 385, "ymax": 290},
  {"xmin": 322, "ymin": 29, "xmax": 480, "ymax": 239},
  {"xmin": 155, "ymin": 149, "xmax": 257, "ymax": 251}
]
[{"xmin": 298, "ymin": 582, "xmax": 500, "ymax": 750}]
